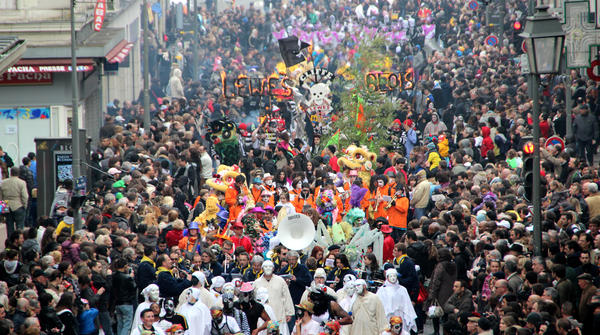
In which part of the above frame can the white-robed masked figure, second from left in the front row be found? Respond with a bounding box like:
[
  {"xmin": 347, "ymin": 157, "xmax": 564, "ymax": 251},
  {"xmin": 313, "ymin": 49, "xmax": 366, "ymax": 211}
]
[{"xmin": 177, "ymin": 288, "xmax": 212, "ymax": 335}]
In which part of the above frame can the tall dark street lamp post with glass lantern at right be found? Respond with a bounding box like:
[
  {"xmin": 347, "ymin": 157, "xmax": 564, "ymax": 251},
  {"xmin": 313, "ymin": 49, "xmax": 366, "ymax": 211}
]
[{"xmin": 521, "ymin": 6, "xmax": 565, "ymax": 256}]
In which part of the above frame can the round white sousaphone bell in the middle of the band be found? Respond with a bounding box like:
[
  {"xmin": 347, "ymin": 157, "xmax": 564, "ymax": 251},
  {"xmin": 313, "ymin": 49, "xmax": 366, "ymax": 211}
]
[{"xmin": 277, "ymin": 213, "xmax": 316, "ymax": 250}]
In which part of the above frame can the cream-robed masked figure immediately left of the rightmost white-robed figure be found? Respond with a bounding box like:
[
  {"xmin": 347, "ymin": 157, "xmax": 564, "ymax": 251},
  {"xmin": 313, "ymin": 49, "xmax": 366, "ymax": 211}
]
[{"xmin": 350, "ymin": 279, "xmax": 388, "ymax": 335}]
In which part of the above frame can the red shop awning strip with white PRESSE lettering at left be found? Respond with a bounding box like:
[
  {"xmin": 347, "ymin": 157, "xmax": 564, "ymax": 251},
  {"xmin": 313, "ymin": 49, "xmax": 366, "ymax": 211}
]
[{"xmin": 8, "ymin": 58, "xmax": 95, "ymax": 73}]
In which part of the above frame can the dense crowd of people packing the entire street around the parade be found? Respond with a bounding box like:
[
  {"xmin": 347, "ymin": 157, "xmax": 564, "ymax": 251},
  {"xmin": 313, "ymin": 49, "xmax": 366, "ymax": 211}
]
[{"xmin": 0, "ymin": 0, "xmax": 600, "ymax": 335}]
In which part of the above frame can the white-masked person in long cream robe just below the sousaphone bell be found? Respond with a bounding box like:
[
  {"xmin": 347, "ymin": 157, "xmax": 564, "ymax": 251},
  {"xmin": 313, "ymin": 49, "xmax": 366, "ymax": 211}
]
[{"xmin": 254, "ymin": 261, "xmax": 294, "ymax": 335}]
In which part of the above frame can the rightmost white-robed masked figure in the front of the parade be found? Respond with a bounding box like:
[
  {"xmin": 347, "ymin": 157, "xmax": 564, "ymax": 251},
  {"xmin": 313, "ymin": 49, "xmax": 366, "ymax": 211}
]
[{"xmin": 377, "ymin": 268, "xmax": 417, "ymax": 332}]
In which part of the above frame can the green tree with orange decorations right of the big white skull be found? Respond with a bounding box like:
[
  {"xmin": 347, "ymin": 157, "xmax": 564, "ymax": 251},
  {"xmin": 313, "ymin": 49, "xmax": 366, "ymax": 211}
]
[{"xmin": 325, "ymin": 38, "xmax": 396, "ymax": 151}]
